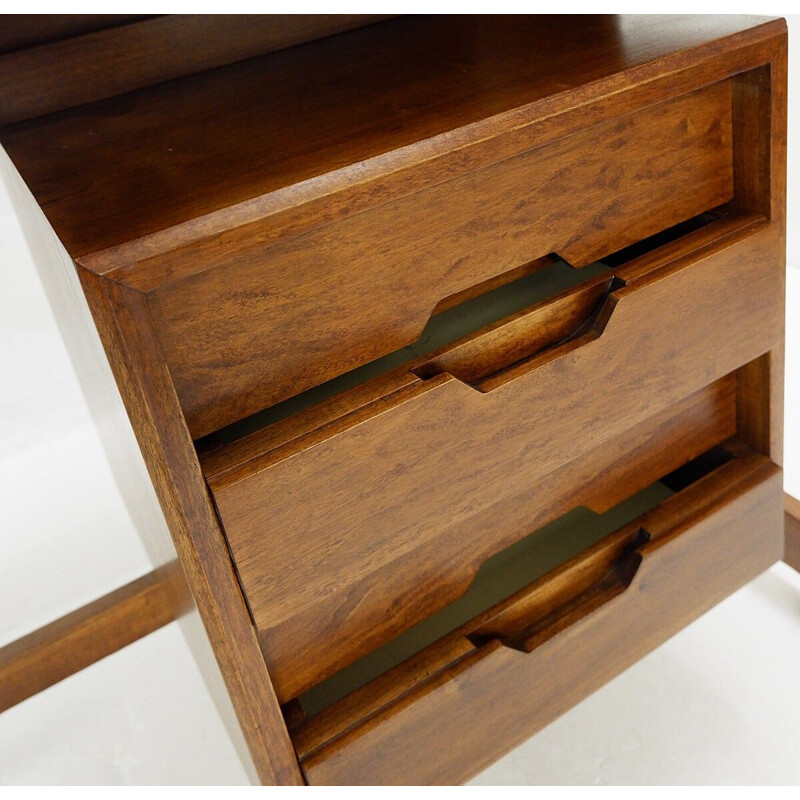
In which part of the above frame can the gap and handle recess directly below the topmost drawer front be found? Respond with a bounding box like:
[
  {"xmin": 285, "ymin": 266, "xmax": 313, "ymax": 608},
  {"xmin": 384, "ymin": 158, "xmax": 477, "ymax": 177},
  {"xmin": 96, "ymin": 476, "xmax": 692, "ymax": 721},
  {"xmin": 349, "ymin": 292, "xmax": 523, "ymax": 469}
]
[{"xmin": 196, "ymin": 203, "xmax": 752, "ymax": 454}]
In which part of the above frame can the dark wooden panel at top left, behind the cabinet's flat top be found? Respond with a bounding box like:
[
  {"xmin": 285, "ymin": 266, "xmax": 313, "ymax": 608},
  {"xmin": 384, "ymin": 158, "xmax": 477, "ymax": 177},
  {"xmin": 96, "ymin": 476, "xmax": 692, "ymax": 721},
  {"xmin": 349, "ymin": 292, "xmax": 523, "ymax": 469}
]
[{"xmin": 0, "ymin": 14, "xmax": 386, "ymax": 125}]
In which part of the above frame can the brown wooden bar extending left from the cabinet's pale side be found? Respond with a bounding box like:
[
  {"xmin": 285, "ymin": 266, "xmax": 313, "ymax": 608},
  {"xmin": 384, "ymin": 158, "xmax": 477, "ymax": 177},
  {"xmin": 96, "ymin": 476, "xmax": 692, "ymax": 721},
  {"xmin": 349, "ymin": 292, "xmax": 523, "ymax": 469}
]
[{"xmin": 0, "ymin": 563, "xmax": 186, "ymax": 712}]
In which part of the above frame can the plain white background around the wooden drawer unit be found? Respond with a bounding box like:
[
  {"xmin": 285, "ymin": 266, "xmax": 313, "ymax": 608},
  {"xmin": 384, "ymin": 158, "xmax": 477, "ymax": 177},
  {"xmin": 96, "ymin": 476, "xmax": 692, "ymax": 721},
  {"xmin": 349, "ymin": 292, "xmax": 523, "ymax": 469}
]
[{"xmin": 0, "ymin": 10, "xmax": 800, "ymax": 784}]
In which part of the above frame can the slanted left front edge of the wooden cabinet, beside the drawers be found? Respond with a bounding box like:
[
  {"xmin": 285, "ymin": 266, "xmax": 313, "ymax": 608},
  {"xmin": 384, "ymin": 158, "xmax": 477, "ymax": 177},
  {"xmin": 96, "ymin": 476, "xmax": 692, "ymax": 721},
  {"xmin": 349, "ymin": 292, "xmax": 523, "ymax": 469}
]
[{"xmin": 78, "ymin": 268, "xmax": 302, "ymax": 784}]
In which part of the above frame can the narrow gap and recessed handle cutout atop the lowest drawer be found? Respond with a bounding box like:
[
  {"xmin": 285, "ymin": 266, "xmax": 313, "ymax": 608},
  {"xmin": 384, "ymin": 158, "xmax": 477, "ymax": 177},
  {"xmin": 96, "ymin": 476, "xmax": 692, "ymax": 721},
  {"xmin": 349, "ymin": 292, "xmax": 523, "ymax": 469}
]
[{"xmin": 300, "ymin": 439, "xmax": 752, "ymax": 718}]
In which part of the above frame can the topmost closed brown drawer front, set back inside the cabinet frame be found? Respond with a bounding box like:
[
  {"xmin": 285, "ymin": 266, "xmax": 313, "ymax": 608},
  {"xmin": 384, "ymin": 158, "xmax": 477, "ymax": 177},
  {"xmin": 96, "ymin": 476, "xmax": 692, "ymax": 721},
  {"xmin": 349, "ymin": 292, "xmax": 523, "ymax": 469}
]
[{"xmin": 153, "ymin": 82, "xmax": 733, "ymax": 438}]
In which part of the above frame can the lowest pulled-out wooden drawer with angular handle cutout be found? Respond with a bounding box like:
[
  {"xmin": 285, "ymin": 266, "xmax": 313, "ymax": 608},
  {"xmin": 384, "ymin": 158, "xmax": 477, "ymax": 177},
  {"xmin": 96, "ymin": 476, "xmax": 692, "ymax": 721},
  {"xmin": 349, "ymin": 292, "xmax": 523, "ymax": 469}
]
[{"xmin": 293, "ymin": 445, "xmax": 783, "ymax": 784}]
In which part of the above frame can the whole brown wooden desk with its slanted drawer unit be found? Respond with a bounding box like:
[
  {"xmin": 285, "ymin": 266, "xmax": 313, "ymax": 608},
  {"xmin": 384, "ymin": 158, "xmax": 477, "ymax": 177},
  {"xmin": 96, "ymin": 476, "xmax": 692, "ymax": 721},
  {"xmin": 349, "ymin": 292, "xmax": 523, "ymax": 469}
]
[{"xmin": 0, "ymin": 16, "xmax": 800, "ymax": 783}]
